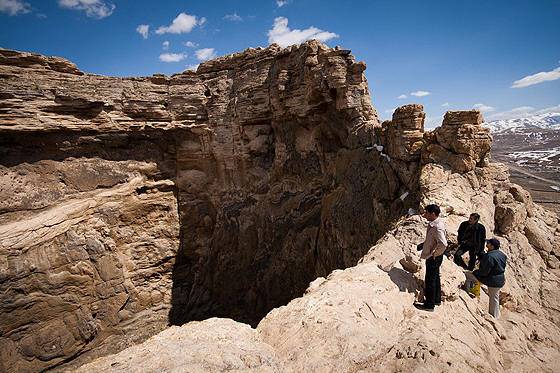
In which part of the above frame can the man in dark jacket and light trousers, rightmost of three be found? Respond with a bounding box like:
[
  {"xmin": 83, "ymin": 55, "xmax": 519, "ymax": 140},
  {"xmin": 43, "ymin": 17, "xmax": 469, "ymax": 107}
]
[{"xmin": 466, "ymin": 238, "xmax": 507, "ymax": 319}]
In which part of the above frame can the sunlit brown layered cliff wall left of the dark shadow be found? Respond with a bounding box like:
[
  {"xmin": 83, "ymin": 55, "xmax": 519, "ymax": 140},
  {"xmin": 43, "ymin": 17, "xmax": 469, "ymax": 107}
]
[{"xmin": 0, "ymin": 51, "xmax": 180, "ymax": 372}]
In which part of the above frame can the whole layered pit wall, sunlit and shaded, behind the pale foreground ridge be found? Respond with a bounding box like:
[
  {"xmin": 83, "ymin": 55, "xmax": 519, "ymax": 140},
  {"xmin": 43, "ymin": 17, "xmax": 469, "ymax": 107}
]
[{"xmin": 0, "ymin": 42, "xmax": 417, "ymax": 371}]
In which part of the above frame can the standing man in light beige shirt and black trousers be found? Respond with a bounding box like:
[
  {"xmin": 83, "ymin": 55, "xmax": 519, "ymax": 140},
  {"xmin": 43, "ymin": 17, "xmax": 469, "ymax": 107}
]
[{"xmin": 414, "ymin": 205, "xmax": 447, "ymax": 311}]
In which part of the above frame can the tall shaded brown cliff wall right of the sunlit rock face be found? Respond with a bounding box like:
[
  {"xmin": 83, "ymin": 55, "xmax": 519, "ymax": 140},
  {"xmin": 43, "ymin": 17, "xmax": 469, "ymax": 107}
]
[{"xmin": 171, "ymin": 42, "xmax": 414, "ymax": 324}]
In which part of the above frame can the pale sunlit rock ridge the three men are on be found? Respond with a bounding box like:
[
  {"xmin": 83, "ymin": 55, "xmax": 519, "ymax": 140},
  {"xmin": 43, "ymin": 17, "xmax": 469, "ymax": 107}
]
[{"xmin": 78, "ymin": 106, "xmax": 560, "ymax": 372}]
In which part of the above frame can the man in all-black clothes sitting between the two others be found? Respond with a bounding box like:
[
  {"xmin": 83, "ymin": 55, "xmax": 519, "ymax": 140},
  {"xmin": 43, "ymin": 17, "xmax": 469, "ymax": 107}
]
[{"xmin": 453, "ymin": 212, "xmax": 486, "ymax": 271}]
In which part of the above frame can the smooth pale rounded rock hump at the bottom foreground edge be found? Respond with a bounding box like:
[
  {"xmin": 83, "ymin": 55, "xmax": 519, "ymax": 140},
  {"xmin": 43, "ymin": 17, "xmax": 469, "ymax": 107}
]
[{"xmin": 76, "ymin": 318, "xmax": 282, "ymax": 373}]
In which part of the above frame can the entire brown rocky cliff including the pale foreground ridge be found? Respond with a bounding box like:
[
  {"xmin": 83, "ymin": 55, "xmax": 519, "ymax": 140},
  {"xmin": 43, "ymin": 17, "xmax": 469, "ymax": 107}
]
[{"xmin": 0, "ymin": 41, "xmax": 560, "ymax": 372}]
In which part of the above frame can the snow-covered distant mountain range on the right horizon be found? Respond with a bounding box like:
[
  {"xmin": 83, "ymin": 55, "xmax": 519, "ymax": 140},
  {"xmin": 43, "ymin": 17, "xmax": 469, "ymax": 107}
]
[{"xmin": 484, "ymin": 113, "xmax": 560, "ymax": 134}]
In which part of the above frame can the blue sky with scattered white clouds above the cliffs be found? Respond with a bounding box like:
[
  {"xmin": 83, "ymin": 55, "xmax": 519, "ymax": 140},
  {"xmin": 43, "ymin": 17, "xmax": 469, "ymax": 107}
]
[{"xmin": 0, "ymin": 0, "xmax": 560, "ymax": 126}]
